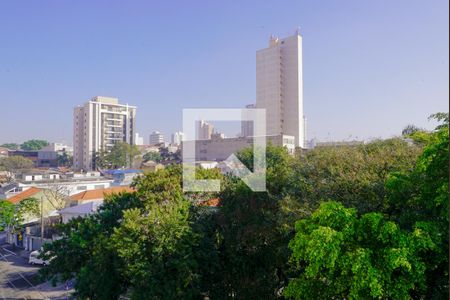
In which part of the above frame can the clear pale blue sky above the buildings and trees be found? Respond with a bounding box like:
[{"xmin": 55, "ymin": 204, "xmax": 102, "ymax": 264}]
[{"xmin": 0, "ymin": 0, "xmax": 449, "ymax": 144}]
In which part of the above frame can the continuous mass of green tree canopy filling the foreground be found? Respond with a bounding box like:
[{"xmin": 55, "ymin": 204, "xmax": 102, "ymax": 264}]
[{"xmin": 42, "ymin": 113, "xmax": 448, "ymax": 299}]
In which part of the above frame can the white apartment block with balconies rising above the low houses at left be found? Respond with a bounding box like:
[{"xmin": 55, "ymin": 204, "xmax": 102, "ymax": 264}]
[{"xmin": 73, "ymin": 96, "xmax": 136, "ymax": 171}]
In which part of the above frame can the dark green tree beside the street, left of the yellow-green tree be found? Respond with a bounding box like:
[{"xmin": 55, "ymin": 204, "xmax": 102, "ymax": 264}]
[{"xmin": 40, "ymin": 193, "xmax": 141, "ymax": 300}]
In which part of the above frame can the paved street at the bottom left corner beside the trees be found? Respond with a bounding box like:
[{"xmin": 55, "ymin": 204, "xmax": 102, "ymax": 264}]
[{"xmin": 0, "ymin": 244, "xmax": 70, "ymax": 299}]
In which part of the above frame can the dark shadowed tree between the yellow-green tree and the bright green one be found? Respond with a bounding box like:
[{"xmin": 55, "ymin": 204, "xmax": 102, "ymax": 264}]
[{"xmin": 212, "ymin": 145, "xmax": 293, "ymax": 299}]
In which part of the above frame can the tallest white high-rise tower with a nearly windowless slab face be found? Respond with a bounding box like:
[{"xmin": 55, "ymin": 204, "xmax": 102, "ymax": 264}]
[{"xmin": 256, "ymin": 31, "xmax": 306, "ymax": 148}]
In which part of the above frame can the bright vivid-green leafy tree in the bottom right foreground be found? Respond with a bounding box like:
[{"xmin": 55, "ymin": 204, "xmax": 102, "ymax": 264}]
[{"xmin": 284, "ymin": 202, "xmax": 430, "ymax": 299}]
